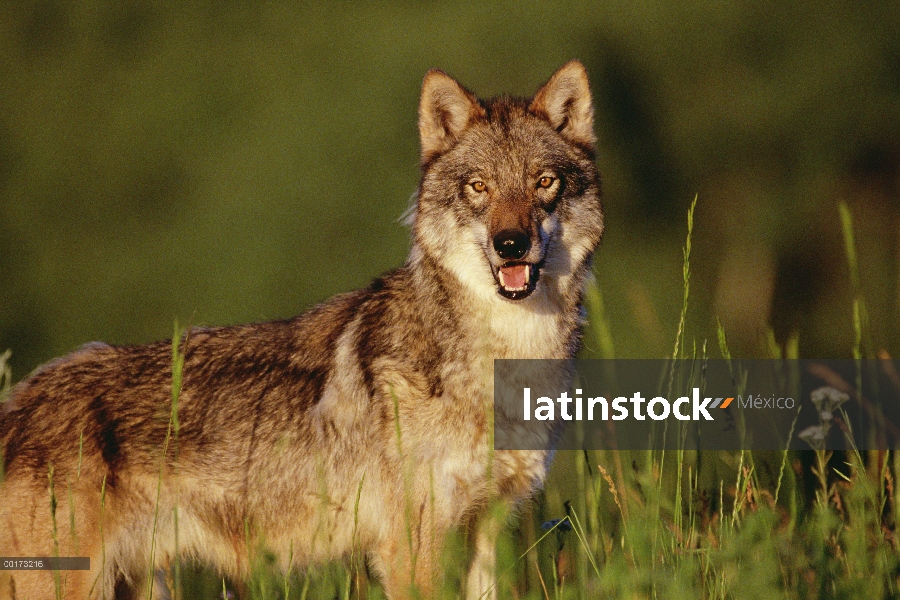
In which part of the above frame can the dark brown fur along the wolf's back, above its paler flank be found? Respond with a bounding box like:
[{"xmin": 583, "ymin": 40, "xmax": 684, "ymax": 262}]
[{"xmin": 0, "ymin": 290, "xmax": 376, "ymax": 480}]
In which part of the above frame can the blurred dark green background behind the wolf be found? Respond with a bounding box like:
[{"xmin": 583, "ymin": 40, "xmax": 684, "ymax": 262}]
[{"xmin": 0, "ymin": 0, "xmax": 900, "ymax": 379}]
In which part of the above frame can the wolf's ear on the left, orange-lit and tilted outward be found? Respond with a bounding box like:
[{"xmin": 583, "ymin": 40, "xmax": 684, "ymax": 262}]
[{"xmin": 419, "ymin": 69, "xmax": 484, "ymax": 163}]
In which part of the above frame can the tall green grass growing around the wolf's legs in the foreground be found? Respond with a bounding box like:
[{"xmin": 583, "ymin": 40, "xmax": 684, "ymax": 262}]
[{"xmin": 0, "ymin": 199, "xmax": 900, "ymax": 600}]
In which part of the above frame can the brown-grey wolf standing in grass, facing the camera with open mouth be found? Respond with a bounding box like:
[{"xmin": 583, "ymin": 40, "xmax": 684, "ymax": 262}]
[{"xmin": 0, "ymin": 61, "xmax": 604, "ymax": 600}]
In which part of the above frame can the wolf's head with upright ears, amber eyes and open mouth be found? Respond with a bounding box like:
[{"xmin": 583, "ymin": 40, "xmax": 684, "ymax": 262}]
[{"xmin": 412, "ymin": 60, "xmax": 603, "ymax": 302}]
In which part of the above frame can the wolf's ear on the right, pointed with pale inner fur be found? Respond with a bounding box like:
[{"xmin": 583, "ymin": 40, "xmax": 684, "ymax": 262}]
[{"xmin": 528, "ymin": 60, "xmax": 596, "ymax": 148}]
